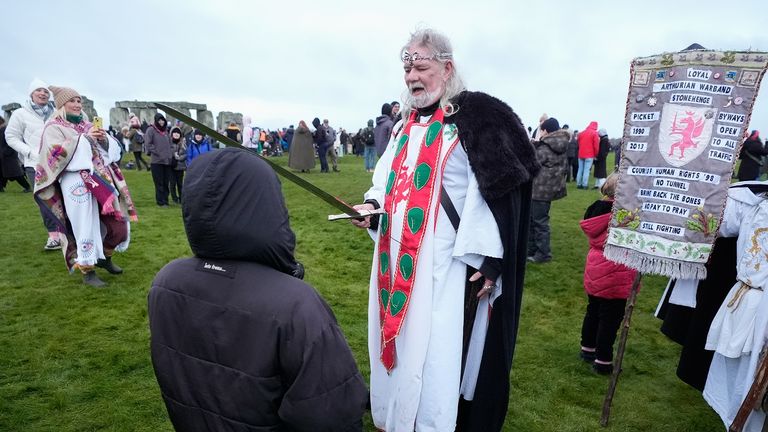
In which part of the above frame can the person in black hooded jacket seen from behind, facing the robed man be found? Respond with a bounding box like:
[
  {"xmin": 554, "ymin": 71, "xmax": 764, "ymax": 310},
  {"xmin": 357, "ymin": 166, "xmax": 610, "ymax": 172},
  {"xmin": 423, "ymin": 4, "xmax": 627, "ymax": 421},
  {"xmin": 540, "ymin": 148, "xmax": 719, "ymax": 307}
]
[{"xmin": 148, "ymin": 148, "xmax": 367, "ymax": 431}]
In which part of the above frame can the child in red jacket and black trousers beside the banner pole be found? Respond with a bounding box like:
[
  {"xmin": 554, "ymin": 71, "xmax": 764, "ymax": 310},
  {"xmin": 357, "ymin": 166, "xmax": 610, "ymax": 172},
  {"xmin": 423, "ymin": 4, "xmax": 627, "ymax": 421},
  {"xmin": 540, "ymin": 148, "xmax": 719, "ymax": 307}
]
[{"xmin": 579, "ymin": 173, "xmax": 637, "ymax": 375}]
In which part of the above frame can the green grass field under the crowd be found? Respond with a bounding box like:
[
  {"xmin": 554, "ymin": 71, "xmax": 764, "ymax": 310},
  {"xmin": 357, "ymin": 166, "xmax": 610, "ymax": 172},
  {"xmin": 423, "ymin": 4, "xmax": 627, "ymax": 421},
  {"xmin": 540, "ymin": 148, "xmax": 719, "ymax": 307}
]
[{"xmin": 0, "ymin": 156, "xmax": 723, "ymax": 432}]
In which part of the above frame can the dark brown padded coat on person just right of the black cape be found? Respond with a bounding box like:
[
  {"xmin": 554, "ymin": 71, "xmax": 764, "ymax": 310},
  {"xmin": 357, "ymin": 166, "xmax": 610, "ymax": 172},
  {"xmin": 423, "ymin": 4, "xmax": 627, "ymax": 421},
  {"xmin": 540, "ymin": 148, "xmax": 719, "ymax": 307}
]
[{"xmin": 533, "ymin": 130, "xmax": 569, "ymax": 201}]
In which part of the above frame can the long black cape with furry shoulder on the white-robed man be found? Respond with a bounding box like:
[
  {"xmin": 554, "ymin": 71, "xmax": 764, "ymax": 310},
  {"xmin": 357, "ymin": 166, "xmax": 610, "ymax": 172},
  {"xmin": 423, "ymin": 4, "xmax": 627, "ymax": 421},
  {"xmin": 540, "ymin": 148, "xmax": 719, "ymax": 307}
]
[{"xmin": 445, "ymin": 92, "xmax": 540, "ymax": 432}]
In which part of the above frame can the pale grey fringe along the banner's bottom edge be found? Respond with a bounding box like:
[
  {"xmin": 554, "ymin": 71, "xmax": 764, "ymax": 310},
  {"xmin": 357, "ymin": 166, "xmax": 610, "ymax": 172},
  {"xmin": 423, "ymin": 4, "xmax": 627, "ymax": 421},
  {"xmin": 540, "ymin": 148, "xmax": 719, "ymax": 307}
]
[{"xmin": 603, "ymin": 244, "xmax": 707, "ymax": 279}]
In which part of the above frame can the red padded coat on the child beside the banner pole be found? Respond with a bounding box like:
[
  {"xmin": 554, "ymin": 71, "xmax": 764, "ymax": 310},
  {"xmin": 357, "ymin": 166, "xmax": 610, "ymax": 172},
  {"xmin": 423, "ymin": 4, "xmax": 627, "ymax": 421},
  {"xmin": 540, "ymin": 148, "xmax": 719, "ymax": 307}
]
[{"xmin": 579, "ymin": 200, "xmax": 637, "ymax": 299}]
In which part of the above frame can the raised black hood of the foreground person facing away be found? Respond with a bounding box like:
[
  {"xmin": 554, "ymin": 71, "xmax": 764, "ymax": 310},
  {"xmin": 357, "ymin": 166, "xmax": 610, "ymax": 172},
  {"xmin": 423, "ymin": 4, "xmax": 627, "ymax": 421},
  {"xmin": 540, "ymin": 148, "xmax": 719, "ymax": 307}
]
[{"xmin": 182, "ymin": 148, "xmax": 296, "ymax": 274}]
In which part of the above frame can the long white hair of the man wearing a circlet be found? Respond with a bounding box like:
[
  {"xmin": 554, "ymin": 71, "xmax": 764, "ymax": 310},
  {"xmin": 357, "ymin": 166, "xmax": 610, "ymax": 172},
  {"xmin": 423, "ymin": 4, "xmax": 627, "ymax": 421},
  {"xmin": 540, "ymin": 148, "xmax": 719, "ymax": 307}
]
[{"xmin": 400, "ymin": 29, "xmax": 466, "ymax": 119}]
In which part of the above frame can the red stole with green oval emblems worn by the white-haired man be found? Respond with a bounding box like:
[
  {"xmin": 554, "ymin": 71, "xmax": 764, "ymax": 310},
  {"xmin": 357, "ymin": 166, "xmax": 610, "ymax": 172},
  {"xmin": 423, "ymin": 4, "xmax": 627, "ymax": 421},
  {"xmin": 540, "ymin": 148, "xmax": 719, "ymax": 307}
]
[{"xmin": 378, "ymin": 109, "xmax": 445, "ymax": 371}]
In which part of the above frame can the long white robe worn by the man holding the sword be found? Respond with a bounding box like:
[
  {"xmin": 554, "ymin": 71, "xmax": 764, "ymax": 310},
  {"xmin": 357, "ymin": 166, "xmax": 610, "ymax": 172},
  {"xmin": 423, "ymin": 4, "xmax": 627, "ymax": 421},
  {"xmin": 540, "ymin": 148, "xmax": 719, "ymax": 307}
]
[{"xmin": 365, "ymin": 117, "xmax": 503, "ymax": 432}]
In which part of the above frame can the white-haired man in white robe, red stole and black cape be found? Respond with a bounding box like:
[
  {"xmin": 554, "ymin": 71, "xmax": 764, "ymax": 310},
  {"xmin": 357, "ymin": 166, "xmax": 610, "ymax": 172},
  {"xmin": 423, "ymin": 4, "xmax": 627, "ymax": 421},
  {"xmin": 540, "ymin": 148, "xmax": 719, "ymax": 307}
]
[{"xmin": 353, "ymin": 30, "xmax": 539, "ymax": 432}]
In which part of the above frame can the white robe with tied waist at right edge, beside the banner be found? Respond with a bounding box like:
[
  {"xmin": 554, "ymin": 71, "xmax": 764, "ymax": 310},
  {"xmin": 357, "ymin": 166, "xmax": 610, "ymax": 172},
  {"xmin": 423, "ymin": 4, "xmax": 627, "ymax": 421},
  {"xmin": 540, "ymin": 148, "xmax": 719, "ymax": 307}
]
[{"xmin": 704, "ymin": 184, "xmax": 768, "ymax": 432}]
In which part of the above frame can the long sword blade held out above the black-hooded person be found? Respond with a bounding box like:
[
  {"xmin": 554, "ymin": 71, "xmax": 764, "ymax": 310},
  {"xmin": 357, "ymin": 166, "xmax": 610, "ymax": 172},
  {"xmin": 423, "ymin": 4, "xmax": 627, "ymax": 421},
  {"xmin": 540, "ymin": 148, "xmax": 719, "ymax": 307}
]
[{"xmin": 155, "ymin": 102, "xmax": 360, "ymax": 217}]
